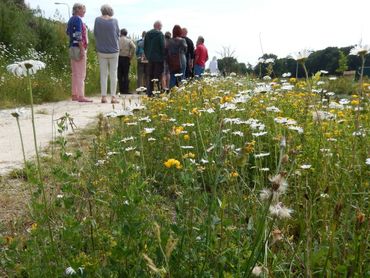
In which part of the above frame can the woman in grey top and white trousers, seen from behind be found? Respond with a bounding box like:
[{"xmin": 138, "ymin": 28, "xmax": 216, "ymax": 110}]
[{"xmin": 94, "ymin": 5, "xmax": 120, "ymax": 103}]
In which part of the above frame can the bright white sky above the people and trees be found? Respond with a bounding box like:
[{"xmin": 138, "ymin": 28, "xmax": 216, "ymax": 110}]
[{"xmin": 25, "ymin": 0, "xmax": 370, "ymax": 65}]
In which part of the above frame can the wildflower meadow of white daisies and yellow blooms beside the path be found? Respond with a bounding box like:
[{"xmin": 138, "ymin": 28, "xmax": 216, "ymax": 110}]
[{"xmin": 0, "ymin": 57, "xmax": 370, "ymax": 277}]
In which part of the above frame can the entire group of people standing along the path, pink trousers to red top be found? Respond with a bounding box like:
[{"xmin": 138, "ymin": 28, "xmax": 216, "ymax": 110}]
[{"xmin": 67, "ymin": 3, "xmax": 208, "ymax": 103}]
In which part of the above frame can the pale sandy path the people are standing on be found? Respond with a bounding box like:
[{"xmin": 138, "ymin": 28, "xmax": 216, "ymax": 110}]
[{"xmin": 0, "ymin": 95, "xmax": 140, "ymax": 176}]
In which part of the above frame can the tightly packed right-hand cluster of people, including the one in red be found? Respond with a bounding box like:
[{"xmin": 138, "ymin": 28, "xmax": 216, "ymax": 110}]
[{"xmin": 136, "ymin": 21, "xmax": 208, "ymax": 96}]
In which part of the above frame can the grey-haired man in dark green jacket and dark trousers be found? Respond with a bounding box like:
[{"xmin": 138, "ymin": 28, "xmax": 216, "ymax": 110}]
[{"xmin": 144, "ymin": 20, "xmax": 164, "ymax": 97}]
